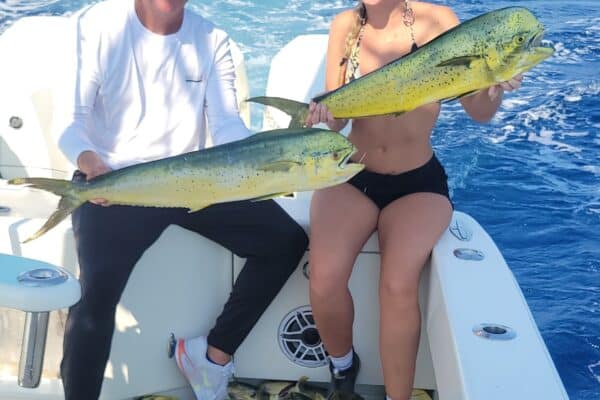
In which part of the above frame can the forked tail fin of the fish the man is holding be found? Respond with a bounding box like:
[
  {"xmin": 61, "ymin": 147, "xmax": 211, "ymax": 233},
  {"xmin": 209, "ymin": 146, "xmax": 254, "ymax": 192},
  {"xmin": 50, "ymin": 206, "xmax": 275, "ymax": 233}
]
[{"xmin": 8, "ymin": 178, "xmax": 86, "ymax": 243}]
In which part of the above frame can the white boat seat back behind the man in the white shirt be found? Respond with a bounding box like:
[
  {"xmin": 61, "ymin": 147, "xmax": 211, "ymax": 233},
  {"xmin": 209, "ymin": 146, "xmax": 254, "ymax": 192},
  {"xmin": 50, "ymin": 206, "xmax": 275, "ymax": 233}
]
[{"xmin": 0, "ymin": 16, "xmax": 250, "ymax": 179}]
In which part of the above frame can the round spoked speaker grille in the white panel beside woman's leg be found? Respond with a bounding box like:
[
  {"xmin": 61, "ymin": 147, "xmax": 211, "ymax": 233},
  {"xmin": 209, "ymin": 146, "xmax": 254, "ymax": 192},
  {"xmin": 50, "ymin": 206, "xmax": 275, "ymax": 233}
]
[{"xmin": 278, "ymin": 306, "xmax": 327, "ymax": 368}]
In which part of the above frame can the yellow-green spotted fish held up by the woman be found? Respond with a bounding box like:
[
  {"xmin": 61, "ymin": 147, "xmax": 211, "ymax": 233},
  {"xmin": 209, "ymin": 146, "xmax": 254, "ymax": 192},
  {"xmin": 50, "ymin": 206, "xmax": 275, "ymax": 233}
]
[{"xmin": 249, "ymin": 7, "xmax": 554, "ymax": 127}]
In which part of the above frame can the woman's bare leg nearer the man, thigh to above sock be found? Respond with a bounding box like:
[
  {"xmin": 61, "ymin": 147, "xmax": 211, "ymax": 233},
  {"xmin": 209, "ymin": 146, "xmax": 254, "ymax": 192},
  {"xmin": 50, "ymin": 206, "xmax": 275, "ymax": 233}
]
[{"xmin": 309, "ymin": 184, "xmax": 379, "ymax": 357}]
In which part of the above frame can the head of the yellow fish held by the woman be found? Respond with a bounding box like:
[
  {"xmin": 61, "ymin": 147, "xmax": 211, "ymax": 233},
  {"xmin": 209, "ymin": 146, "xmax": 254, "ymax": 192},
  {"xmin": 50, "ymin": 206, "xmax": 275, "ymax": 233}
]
[{"xmin": 484, "ymin": 7, "xmax": 554, "ymax": 82}]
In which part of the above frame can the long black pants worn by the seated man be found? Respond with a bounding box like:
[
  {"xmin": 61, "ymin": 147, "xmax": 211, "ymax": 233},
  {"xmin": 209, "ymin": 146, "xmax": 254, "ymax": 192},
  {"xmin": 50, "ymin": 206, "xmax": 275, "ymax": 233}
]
[{"xmin": 61, "ymin": 173, "xmax": 308, "ymax": 400}]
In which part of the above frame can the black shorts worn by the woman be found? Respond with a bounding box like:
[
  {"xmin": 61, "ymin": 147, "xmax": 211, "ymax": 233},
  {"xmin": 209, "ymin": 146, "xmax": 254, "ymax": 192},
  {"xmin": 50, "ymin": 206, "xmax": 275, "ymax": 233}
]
[{"xmin": 348, "ymin": 155, "xmax": 452, "ymax": 210}]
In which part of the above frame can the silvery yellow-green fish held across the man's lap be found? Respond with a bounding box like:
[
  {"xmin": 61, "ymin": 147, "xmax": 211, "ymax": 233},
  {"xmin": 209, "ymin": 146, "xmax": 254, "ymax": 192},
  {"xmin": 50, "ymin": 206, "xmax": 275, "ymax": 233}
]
[{"xmin": 8, "ymin": 129, "xmax": 364, "ymax": 241}]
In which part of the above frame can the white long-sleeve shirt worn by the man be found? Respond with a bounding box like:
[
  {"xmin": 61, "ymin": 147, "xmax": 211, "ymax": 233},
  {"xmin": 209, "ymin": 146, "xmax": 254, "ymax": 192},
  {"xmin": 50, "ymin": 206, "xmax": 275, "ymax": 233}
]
[{"xmin": 58, "ymin": 0, "xmax": 250, "ymax": 169}]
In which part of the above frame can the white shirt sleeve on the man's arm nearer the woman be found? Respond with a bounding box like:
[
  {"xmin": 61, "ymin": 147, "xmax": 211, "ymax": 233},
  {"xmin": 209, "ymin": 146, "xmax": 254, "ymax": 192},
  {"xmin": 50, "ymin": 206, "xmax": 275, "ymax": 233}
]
[{"xmin": 205, "ymin": 32, "xmax": 251, "ymax": 145}]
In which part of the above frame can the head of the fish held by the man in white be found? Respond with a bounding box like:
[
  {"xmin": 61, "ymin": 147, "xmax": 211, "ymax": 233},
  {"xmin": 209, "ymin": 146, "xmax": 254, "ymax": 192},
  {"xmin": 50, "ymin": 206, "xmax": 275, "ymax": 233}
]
[{"xmin": 305, "ymin": 129, "xmax": 364, "ymax": 183}]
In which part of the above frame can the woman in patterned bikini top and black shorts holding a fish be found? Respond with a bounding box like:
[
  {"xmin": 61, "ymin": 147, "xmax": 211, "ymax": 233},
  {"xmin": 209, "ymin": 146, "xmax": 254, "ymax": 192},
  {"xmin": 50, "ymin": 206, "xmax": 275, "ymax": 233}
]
[{"xmin": 306, "ymin": 0, "xmax": 522, "ymax": 400}]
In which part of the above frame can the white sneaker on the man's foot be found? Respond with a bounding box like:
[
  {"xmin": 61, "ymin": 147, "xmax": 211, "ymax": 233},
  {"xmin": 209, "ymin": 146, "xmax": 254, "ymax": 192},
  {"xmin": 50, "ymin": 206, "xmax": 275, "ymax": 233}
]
[{"xmin": 175, "ymin": 336, "xmax": 234, "ymax": 400}]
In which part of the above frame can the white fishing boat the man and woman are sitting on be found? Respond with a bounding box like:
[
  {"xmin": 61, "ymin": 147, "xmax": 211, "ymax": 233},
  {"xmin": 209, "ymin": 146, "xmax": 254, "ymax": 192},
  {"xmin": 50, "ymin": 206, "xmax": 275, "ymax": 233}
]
[{"xmin": 0, "ymin": 16, "xmax": 568, "ymax": 400}]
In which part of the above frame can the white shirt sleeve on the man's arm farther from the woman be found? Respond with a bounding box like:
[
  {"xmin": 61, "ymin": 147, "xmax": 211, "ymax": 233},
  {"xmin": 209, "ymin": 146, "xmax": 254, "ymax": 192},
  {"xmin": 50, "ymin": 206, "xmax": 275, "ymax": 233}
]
[{"xmin": 53, "ymin": 11, "xmax": 100, "ymax": 166}]
